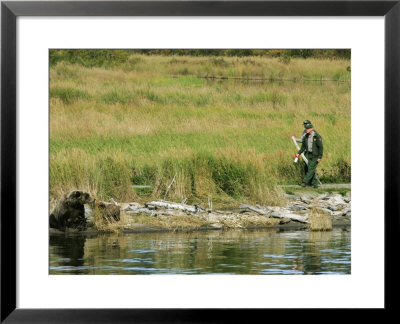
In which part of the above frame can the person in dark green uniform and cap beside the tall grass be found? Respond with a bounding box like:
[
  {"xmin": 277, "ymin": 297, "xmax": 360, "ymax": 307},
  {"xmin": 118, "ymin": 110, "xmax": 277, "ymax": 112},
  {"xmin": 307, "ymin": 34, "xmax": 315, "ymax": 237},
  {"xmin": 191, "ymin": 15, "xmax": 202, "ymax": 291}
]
[{"xmin": 296, "ymin": 120, "xmax": 324, "ymax": 188}]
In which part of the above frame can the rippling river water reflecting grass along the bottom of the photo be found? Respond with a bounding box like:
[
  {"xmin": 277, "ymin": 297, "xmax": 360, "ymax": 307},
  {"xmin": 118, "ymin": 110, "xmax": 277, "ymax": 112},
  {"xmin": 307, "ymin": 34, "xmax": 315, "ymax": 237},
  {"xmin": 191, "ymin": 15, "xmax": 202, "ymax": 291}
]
[{"xmin": 49, "ymin": 228, "xmax": 351, "ymax": 275}]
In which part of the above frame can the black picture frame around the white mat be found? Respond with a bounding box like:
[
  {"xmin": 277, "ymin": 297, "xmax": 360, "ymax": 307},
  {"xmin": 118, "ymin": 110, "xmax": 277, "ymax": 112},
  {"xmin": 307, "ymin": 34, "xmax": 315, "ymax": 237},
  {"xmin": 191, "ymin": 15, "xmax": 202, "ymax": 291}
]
[{"xmin": 1, "ymin": 0, "xmax": 400, "ymax": 323}]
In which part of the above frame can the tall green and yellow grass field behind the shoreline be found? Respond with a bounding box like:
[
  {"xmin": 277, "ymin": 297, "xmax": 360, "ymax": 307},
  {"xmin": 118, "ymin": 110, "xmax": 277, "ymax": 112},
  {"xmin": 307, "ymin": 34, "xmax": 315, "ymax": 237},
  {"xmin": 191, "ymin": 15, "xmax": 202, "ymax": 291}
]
[{"xmin": 49, "ymin": 50, "xmax": 351, "ymax": 230}]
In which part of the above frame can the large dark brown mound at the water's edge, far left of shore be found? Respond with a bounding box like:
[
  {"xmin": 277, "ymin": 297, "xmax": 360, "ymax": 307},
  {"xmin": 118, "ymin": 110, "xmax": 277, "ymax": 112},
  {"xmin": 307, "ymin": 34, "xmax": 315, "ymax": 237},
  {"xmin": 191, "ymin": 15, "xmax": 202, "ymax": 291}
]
[{"xmin": 49, "ymin": 190, "xmax": 94, "ymax": 231}]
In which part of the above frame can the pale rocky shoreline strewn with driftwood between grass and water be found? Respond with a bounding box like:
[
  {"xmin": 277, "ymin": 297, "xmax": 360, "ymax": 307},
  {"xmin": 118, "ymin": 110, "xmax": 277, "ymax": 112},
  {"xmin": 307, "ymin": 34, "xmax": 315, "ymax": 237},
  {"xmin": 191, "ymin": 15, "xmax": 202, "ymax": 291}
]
[{"xmin": 73, "ymin": 192, "xmax": 351, "ymax": 233}]
